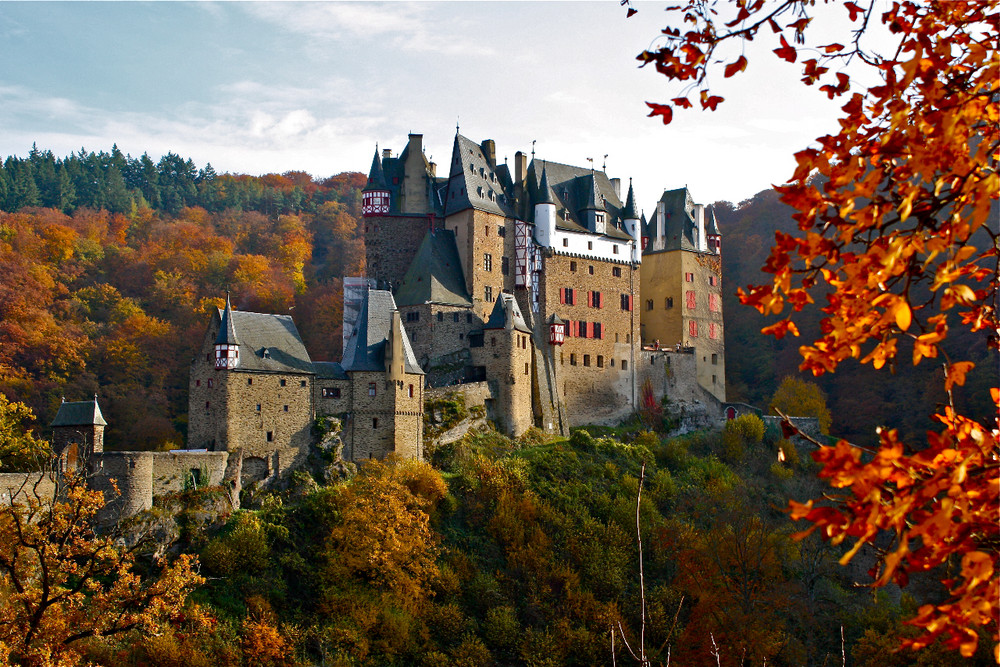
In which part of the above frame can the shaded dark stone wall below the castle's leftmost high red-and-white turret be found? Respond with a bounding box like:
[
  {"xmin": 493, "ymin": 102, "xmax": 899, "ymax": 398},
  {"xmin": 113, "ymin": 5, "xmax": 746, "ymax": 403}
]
[{"xmin": 364, "ymin": 215, "xmax": 432, "ymax": 289}]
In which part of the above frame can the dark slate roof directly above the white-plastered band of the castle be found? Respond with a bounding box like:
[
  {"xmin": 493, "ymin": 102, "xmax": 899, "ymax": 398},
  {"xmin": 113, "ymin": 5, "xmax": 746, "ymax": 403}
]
[{"xmin": 528, "ymin": 160, "xmax": 631, "ymax": 241}]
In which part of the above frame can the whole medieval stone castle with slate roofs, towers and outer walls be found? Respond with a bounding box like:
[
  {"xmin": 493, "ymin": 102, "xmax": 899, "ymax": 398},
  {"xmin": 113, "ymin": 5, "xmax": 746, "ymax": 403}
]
[{"xmin": 0, "ymin": 133, "xmax": 735, "ymax": 514}]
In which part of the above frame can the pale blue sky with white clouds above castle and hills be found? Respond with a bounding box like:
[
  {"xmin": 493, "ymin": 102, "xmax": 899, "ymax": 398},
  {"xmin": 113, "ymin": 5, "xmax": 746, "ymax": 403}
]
[{"xmin": 0, "ymin": 0, "xmax": 860, "ymax": 209}]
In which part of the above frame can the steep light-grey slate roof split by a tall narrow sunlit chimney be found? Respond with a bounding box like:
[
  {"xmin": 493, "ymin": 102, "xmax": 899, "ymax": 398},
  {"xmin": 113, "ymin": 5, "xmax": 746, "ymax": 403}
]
[{"xmin": 340, "ymin": 290, "xmax": 424, "ymax": 375}]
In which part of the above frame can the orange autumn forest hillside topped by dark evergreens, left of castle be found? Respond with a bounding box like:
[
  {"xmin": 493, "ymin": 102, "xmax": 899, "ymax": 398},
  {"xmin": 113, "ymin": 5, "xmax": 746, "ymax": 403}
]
[{"xmin": 0, "ymin": 149, "xmax": 364, "ymax": 449}]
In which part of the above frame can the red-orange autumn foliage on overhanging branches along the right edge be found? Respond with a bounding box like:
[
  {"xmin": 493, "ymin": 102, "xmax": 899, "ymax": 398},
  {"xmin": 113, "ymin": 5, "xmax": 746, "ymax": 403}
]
[{"xmin": 639, "ymin": 0, "xmax": 1000, "ymax": 661}]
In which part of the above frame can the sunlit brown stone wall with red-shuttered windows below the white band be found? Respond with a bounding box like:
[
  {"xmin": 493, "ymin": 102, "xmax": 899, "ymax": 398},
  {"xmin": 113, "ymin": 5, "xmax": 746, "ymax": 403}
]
[{"xmin": 540, "ymin": 255, "xmax": 639, "ymax": 425}]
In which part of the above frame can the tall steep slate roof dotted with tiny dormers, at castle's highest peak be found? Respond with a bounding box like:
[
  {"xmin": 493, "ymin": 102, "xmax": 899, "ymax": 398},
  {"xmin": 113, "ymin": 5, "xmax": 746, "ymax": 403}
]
[{"xmin": 445, "ymin": 134, "xmax": 514, "ymax": 216}]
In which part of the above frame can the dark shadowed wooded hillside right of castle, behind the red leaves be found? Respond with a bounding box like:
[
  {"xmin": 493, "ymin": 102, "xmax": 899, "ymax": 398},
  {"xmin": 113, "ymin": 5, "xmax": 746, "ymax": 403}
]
[{"xmin": 714, "ymin": 190, "xmax": 997, "ymax": 444}]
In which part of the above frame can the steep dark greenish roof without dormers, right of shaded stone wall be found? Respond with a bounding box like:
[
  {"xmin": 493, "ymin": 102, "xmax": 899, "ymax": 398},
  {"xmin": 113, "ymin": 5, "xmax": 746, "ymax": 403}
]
[{"xmin": 395, "ymin": 229, "xmax": 472, "ymax": 307}]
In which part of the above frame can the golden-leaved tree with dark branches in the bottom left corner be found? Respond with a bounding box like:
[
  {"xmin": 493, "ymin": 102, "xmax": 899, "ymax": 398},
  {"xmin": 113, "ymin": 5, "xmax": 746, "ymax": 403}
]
[{"xmin": 0, "ymin": 478, "xmax": 202, "ymax": 665}]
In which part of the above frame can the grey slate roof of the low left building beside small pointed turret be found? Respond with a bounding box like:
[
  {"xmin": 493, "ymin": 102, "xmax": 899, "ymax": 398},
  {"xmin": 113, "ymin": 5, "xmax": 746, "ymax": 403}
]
[{"xmin": 218, "ymin": 310, "xmax": 313, "ymax": 373}]
